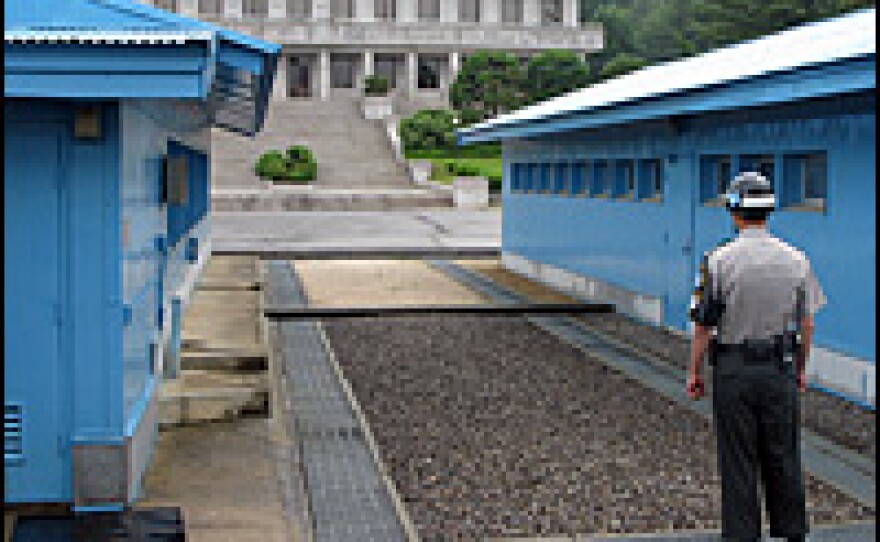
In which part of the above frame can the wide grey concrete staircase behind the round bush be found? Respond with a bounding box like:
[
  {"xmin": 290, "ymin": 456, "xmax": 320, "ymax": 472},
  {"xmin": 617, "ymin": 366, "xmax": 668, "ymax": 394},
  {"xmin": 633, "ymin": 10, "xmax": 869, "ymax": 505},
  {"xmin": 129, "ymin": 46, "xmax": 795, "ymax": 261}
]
[{"xmin": 211, "ymin": 99, "xmax": 412, "ymax": 190}]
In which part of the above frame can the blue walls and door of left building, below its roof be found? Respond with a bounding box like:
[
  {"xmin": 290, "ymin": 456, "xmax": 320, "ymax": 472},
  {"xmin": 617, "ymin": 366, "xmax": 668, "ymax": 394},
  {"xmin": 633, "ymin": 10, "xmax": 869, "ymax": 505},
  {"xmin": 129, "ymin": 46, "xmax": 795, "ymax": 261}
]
[{"xmin": 4, "ymin": 100, "xmax": 209, "ymax": 502}]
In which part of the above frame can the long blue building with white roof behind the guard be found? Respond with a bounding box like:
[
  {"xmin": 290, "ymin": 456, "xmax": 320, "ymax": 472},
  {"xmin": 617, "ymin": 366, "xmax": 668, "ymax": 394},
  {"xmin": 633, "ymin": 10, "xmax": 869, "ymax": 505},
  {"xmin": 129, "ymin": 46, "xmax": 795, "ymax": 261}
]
[{"xmin": 459, "ymin": 9, "xmax": 876, "ymax": 408}]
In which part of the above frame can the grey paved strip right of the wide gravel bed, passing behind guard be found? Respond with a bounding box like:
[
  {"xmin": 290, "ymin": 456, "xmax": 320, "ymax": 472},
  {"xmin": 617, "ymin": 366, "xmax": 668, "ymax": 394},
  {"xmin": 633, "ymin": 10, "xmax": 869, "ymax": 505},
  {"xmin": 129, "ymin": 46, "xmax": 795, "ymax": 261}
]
[{"xmin": 427, "ymin": 261, "xmax": 876, "ymax": 507}]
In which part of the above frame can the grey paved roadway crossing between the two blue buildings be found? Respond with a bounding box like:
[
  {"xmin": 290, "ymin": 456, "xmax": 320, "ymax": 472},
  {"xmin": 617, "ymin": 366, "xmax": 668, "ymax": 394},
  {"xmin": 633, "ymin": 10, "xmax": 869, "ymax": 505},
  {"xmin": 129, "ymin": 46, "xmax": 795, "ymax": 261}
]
[{"xmin": 211, "ymin": 210, "xmax": 501, "ymax": 259}]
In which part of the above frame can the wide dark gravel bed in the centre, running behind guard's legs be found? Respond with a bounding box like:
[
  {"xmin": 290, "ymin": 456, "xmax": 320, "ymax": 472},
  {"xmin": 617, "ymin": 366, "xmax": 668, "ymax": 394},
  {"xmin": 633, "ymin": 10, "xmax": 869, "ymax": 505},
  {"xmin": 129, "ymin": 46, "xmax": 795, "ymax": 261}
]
[{"xmin": 325, "ymin": 317, "xmax": 874, "ymax": 540}]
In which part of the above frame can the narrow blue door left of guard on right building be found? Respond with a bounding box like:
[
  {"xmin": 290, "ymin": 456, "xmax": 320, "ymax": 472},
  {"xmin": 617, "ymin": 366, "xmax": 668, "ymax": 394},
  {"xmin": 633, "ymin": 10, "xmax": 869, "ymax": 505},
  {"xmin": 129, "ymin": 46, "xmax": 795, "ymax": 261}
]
[{"xmin": 663, "ymin": 155, "xmax": 696, "ymax": 329}]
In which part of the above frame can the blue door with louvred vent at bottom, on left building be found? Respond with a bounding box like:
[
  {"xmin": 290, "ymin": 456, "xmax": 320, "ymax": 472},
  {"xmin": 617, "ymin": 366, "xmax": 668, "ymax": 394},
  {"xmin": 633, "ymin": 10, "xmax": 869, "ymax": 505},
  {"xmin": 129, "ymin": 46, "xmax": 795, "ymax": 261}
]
[{"xmin": 3, "ymin": 120, "xmax": 70, "ymax": 502}]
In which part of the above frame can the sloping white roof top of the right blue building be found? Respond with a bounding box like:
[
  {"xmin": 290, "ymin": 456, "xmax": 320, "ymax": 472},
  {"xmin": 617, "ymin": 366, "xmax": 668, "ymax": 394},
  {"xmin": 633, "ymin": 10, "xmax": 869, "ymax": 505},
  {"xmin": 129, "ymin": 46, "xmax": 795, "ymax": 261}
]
[{"xmin": 461, "ymin": 9, "xmax": 877, "ymax": 134}]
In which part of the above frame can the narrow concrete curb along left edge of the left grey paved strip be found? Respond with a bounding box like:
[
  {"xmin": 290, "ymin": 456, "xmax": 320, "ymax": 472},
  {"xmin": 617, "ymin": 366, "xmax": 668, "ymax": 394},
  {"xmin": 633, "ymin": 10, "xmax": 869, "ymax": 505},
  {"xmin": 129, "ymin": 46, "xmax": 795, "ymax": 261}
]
[{"xmin": 257, "ymin": 260, "xmax": 314, "ymax": 542}]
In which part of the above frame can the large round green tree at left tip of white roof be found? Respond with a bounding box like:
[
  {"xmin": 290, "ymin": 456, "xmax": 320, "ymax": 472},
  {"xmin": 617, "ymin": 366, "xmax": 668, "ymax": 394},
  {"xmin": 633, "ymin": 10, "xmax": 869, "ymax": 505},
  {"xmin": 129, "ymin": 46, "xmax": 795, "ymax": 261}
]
[{"xmin": 449, "ymin": 51, "xmax": 525, "ymax": 121}]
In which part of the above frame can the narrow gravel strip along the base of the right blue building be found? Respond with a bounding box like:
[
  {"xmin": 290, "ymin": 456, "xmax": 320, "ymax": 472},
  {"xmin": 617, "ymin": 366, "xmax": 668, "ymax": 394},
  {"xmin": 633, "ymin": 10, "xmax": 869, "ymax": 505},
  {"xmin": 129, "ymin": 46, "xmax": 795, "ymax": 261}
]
[{"xmin": 464, "ymin": 262, "xmax": 877, "ymax": 459}]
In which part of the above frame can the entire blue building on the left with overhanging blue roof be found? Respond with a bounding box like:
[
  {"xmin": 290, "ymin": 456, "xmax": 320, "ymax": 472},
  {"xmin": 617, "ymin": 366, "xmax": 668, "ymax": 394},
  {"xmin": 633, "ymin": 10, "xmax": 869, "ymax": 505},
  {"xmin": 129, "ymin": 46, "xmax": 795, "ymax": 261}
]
[{"xmin": 3, "ymin": 0, "xmax": 279, "ymax": 510}]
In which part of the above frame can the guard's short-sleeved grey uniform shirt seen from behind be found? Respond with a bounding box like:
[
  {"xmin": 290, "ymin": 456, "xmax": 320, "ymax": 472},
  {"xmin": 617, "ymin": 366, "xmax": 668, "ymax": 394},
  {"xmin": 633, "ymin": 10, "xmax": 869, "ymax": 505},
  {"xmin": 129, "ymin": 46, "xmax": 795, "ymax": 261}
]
[{"xmin": 691, "ymin": 228, "xmax": 825, "ymax": 344}]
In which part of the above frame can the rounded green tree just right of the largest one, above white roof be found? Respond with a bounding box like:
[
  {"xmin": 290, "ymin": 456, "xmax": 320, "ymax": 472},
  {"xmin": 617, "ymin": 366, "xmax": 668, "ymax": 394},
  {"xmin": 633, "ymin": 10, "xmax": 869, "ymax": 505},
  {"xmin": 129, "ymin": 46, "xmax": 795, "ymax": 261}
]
[{"xmin": 523, "ymin": 50, "xmax": 590, "ymax": 103}]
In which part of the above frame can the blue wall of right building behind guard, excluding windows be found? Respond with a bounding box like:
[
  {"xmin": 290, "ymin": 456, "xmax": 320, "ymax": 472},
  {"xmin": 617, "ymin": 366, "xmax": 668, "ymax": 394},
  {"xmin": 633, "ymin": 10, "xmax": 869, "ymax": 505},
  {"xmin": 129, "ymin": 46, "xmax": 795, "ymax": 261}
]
[{"xmin": 503, "ymin": 94, "xmax": 876, "ymax": 360}]
